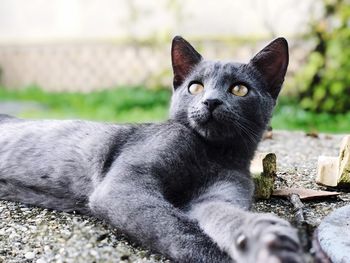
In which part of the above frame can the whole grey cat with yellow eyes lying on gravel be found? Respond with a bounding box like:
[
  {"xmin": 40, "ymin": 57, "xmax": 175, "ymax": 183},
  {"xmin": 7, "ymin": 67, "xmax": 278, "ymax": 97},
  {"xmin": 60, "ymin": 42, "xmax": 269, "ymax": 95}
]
[{"xmin": 0, "ymin": 36, "xmax": 303, "ymax": 263}]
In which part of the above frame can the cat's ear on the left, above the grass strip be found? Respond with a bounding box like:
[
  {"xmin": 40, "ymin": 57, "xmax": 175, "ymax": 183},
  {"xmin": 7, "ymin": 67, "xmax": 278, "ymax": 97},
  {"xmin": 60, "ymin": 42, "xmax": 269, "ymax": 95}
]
[{"xmin": 171, "ymin": 36, "xmax": 202, "ymax": 89}]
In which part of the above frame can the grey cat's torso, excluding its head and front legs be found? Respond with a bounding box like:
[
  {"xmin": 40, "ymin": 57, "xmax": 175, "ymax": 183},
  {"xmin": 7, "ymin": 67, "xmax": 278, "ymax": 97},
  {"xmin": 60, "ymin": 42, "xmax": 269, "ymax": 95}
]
[{"xmin": 0, "ymin": 118, "xmax": 250, "ymax": 213}]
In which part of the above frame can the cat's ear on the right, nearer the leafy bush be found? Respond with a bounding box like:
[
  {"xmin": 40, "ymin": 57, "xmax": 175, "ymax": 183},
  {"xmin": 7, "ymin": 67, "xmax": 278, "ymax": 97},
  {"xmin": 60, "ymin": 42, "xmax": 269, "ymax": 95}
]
[{"xmin": 249, "ymin": 37, "xmax": 289, "ymax": 99}]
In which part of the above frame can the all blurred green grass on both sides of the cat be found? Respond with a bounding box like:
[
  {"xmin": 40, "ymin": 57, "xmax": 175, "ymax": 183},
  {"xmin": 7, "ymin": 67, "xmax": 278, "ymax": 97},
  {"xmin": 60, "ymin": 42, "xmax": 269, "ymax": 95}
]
[{"xmin": 0, "ymin": 87, "xmax": 350, "ymax": 133}]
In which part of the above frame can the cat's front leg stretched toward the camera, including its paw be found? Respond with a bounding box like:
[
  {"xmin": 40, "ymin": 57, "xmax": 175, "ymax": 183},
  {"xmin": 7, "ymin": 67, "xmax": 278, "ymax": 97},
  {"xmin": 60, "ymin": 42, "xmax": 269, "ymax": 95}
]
[{"xmin": 187, "ymin": 180, "xmax": 303, "ymax": 263}]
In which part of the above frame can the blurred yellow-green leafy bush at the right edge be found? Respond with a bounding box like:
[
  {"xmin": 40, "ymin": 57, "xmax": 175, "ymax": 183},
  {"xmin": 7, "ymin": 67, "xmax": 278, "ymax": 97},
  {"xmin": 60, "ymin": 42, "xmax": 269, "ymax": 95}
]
[{"xmin": 296, "ymin": 0, "xmax": 350, "ymax": 113}]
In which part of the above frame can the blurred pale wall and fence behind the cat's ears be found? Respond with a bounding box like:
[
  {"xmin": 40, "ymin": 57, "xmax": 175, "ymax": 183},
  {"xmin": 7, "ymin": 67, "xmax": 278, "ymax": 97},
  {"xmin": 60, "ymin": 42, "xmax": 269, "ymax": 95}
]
[{"xmin": 0, "ymin": 0, "xmax": 319, "ymax": 91}]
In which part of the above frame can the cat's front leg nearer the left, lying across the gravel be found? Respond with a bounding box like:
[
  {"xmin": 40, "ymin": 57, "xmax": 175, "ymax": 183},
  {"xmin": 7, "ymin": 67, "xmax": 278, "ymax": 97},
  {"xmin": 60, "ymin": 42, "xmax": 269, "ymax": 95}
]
[{"xmin": 89, "ymin": 175, "xmax": 232, "ymax": 263}]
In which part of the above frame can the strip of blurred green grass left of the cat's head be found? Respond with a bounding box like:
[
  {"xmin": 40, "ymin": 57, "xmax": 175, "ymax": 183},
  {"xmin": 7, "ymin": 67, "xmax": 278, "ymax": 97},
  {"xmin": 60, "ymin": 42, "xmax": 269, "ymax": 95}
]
[{"xmin": 0, "ymin": 87, "xmax": 171, "ymax": 122}]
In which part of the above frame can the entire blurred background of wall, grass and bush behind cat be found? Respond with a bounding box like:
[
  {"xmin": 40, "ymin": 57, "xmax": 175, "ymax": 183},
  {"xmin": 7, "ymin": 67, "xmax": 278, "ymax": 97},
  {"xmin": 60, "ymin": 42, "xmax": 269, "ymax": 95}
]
[{"xmin": 0, "ymin": 0, "xmax": 350, "ymax": 133}]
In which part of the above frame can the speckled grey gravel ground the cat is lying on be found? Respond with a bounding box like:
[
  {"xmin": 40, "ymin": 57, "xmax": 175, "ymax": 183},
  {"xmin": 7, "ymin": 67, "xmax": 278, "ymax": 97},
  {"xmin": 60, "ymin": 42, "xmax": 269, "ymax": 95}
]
[{"xmin": 0, "ymin": 132, "xmax": 350, "ymax": 263}]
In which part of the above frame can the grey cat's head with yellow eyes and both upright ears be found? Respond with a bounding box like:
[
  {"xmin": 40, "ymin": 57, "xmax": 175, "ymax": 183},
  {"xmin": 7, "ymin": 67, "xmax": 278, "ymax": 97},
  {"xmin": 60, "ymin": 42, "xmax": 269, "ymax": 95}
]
[{"xmin": 170, "ymin": 36, "xmax": 288, "ymax": 145}]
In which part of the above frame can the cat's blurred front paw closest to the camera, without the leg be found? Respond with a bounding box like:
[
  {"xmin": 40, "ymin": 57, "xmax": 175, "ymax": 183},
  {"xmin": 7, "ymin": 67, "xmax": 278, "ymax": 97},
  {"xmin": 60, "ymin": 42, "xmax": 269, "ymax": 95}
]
[{"xmin": 231, "ymin": 214, "xmax": 304, "ymax": 263}]
